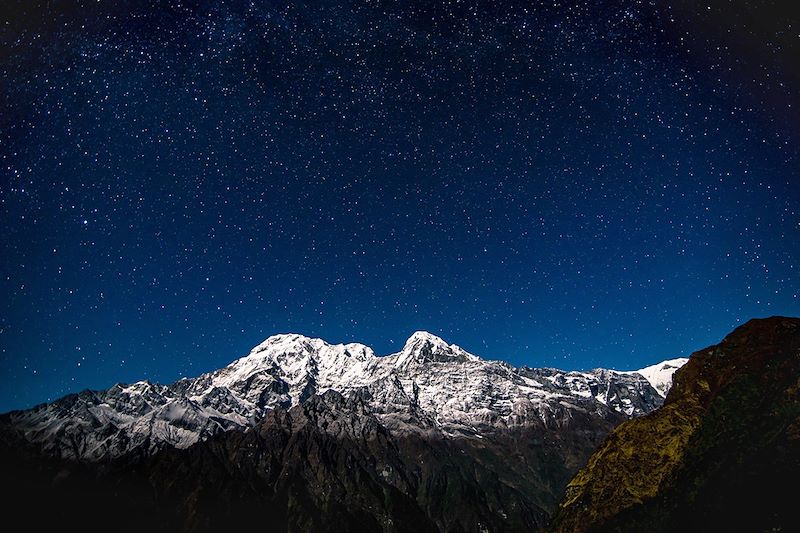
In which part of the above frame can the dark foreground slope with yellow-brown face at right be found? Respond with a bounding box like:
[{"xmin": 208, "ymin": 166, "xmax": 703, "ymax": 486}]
[{"xmin": 553, "ymin": 317, "xmax": 800, "ymax": 532}]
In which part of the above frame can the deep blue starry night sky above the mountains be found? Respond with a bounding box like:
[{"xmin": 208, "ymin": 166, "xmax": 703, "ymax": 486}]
[{"xmin": 0, "ymin": 0, "xmax": 800, "ymax": 411}]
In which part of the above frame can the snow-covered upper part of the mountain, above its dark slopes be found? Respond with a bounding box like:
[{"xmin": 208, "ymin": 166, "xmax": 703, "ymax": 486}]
[{"xmin": 0, "ymin": 331, "xmax": 677, "ymax": 460}]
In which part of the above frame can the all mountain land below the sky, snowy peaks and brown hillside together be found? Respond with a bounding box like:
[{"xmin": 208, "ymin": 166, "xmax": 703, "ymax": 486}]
[{"xmin": 6, "ymin": 317, "xmax": 800, "ymax": 533}]
